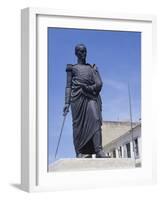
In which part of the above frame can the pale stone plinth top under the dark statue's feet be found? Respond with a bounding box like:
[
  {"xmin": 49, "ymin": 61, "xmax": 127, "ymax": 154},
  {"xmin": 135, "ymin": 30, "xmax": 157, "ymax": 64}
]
[{"xmin": 49, "ymin": 158, "xmax": 135, "ymax": 172}]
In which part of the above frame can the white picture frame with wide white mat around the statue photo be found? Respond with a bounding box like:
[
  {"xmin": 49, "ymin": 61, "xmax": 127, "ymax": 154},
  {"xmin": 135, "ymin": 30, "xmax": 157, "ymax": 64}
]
[{"xmin": 21, "ymin": 8, "xmax": 156, "ymax": 192}]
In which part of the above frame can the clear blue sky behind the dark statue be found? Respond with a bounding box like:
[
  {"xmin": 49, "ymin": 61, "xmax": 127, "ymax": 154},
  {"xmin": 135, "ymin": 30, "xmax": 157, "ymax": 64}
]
[{"xmin": 48, "ymin": 28, "xmax": 141, "ymax": 163}]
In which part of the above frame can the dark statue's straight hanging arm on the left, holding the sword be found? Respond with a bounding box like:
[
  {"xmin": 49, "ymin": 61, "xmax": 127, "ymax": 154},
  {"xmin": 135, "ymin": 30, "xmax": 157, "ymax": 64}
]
[{"xmin": 63, "ymin": 65, "xmax": 72, "ymax": 115}]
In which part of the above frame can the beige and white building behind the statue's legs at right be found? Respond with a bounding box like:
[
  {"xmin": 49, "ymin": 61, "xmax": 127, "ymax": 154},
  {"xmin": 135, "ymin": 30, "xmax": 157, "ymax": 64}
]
[{"xmin": 102, "ymin": 121, "xmax": 141, "ymax": 160}]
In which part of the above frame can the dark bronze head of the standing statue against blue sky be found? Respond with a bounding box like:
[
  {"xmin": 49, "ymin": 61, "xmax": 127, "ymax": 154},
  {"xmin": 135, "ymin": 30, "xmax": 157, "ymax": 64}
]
[{"xmin": 75, "ymin": 44, "xmax": 87, "ymax": 60}]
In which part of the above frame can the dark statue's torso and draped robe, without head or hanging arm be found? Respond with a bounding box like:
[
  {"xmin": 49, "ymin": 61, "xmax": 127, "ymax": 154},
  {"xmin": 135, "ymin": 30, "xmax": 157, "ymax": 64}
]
[{"xmin": 67, "ymin": 64, "xmax": 102, "ymax": 154}]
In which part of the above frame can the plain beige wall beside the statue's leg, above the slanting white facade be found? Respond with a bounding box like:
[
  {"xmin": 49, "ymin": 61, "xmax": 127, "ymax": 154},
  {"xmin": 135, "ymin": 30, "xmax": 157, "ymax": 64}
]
[{"xmin": 102, "ymin": 121, "xmax": 140, "ymax": 146}]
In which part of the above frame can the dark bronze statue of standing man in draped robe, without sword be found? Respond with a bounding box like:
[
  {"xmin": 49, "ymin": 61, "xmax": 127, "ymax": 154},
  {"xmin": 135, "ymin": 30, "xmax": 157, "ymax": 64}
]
[{"xmin": 63, "ymin": 44, "xmax": 107, "ymax": 158}]
